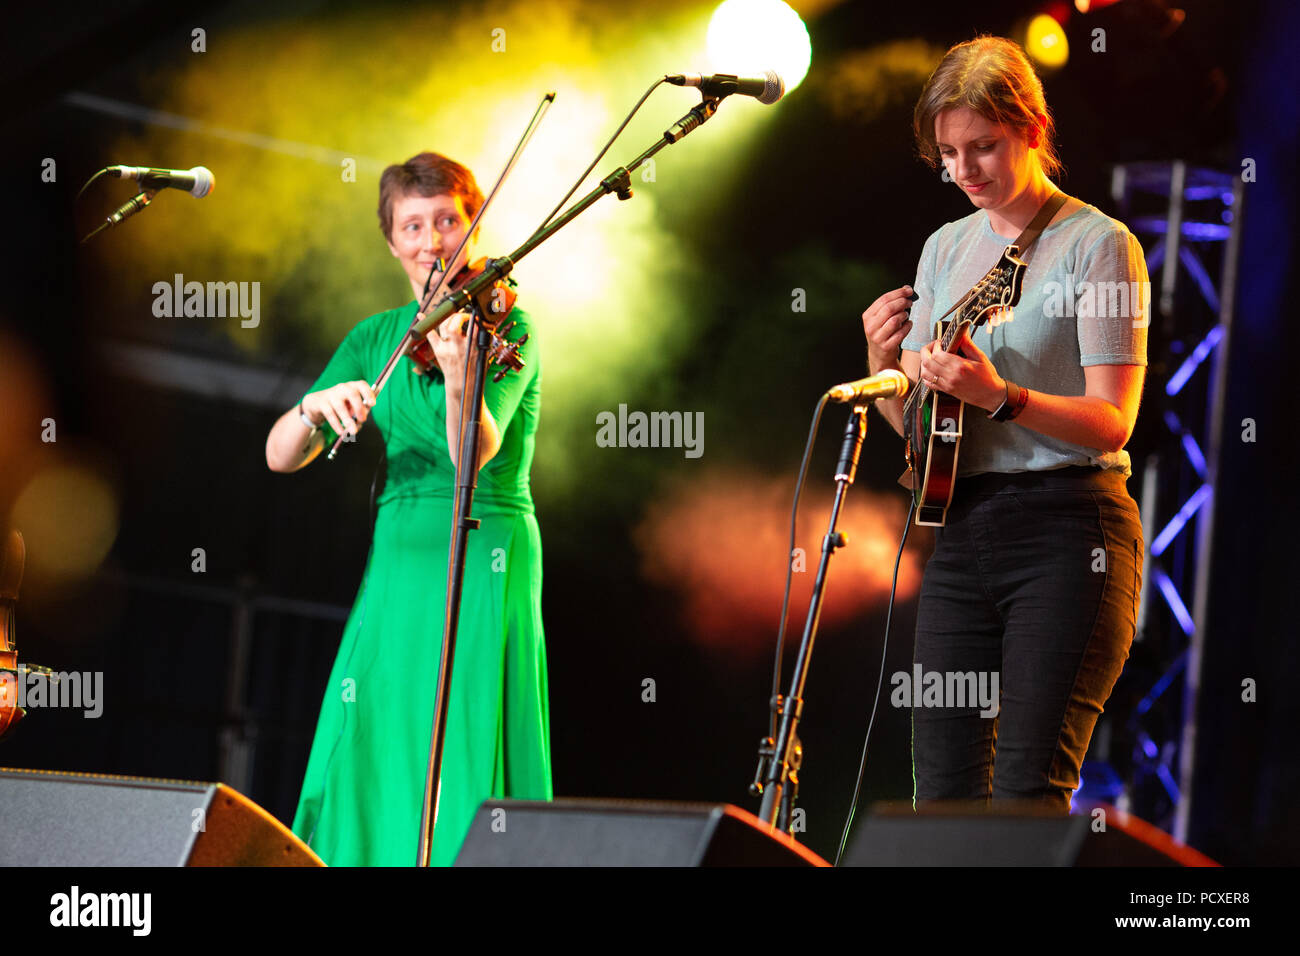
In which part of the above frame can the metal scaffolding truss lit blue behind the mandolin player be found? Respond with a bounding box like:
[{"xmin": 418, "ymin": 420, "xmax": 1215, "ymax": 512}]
[{"xmin": 1110, "ymin": 160, "xmax": 1244, "ymax": 840}]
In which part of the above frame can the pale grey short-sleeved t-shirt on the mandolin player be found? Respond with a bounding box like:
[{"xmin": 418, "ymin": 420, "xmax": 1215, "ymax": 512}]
[{"xmin": 902, "ymin": 206, "xmax": 1151, "ymax": 476}]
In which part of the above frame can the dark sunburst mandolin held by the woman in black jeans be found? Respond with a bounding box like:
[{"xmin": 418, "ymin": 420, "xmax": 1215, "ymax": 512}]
[{"xmin": 900, "ymin": 243, "xmax": 1026, "ymax": 527}]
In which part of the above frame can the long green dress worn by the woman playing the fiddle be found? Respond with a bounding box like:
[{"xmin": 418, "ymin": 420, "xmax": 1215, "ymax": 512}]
[{"xmin": 293, "ymin": 300, "xmax": 551, "ymax": 866}]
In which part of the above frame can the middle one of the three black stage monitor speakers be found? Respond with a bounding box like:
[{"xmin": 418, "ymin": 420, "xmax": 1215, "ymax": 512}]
[{"xmin": 455, "ymin": 800, "xmax": 828, "ymax": 866}]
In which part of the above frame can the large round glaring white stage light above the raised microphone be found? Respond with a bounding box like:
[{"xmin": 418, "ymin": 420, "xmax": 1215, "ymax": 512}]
[{"xmin": 709, "ymin": 0, "xmax": 813, "ymax": 94}]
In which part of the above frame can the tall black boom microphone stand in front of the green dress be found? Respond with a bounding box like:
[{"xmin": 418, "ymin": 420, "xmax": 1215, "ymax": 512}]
[{"xmin": 421, "ymin": 96, "xmax": 738, "ymax": 866}]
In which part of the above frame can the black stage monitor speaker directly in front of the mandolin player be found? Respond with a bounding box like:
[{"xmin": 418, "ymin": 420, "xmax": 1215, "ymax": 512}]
[{"xmin": 841, "ymin": 803, "xmax": 1218, "ymax": 866}]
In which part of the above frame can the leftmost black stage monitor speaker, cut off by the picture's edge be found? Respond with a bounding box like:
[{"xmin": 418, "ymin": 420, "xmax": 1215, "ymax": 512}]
[{"xmin": 0, "ymin": 769, "xmax": 324, "ymax": 866}]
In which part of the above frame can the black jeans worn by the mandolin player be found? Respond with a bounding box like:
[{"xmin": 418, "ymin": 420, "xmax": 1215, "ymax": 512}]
[{"xmin": 911, "ymin": 468, "xmax": 1143, "ymax": 813}]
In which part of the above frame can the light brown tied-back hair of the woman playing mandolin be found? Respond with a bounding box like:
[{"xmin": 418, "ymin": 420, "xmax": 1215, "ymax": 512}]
[{"xmin": 911, "ymin": 36, "xmax": 1062, "ymax": 182}]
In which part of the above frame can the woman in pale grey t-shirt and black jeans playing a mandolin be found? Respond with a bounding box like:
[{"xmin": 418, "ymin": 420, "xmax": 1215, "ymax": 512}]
[{"xmin": 862, "ymin": 36, "xmax": 1149, "ymax": 813}]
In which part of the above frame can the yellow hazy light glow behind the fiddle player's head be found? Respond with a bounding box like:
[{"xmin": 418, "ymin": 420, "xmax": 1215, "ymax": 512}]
[{"xmin": 89, "ymin": 0, "xmax": 790, "ymax": 502}]
